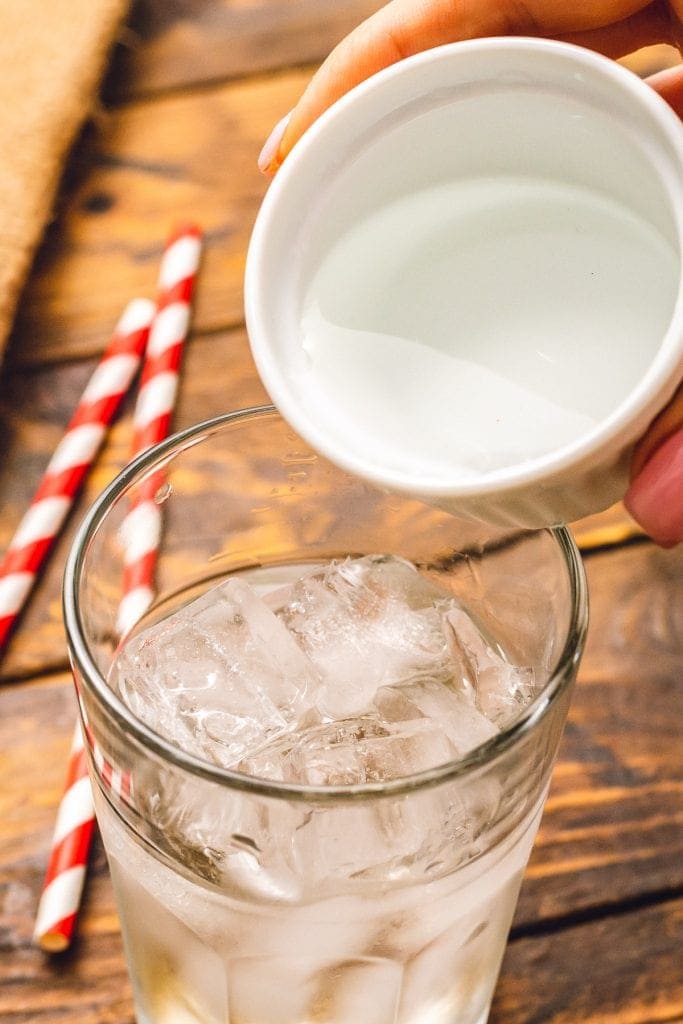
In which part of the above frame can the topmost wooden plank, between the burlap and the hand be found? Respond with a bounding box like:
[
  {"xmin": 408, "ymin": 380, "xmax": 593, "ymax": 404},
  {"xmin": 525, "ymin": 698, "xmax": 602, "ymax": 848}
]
[{"xmin": 104, "ymin": 0, "xmax": 383, "ymax": 102}]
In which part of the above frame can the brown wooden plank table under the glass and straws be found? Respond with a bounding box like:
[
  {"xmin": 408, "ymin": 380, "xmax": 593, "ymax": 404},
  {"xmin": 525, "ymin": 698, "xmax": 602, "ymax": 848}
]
[{"xmin": 0, "ymin": 0, "xmax": 683, "ymax": 1024}]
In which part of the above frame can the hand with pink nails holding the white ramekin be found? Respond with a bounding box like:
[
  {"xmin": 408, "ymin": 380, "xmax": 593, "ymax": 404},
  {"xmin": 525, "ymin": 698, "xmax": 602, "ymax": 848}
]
[{"xmin": 259, "ymin": 0, "xmax": 683, "ymax": 547}]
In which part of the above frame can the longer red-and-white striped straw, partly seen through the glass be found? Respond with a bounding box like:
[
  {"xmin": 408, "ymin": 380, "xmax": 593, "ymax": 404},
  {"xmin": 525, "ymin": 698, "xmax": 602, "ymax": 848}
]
[{"xmin": 34, "ymin": 227, "xmax": 201, "ymax": 952}]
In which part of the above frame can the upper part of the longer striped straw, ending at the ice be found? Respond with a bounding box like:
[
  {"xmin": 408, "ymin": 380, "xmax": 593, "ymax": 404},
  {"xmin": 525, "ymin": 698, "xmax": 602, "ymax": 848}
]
[{"xmin": 117, "ymin": 225, "xmax": 202, "ymax": 637}]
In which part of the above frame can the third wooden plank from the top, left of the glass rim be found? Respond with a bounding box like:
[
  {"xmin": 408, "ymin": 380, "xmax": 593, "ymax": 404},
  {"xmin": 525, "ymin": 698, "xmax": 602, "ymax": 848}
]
[{"xmin": 0, "ymin": 330, "xmax": 267, "ymax": 679}]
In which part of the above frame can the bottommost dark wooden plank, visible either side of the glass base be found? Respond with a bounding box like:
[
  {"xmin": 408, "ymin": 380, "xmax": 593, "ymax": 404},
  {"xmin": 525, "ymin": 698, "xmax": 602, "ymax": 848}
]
[{"xmin": 0, "ymin": 850, "xmax": 683, "ymax": 1024}]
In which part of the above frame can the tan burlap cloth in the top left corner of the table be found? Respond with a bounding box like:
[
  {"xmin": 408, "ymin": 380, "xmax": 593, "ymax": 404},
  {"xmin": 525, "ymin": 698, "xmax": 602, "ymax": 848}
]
[{"xmin": 0, "ymin": 0, "xmax": 128, "ymax": 357}]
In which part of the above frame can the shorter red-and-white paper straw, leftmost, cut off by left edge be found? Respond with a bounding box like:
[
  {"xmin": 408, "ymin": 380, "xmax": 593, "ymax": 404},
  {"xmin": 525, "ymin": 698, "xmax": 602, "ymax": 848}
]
[{"xmin": 0, "ymin": 299, "xmax": 155, "ymax": 651}]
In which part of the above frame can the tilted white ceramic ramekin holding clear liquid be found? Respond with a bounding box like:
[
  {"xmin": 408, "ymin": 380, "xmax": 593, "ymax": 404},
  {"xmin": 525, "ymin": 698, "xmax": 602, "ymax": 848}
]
[{"xmin": 246, "ymin": 39, "xmax": 683, "ymax": 526}]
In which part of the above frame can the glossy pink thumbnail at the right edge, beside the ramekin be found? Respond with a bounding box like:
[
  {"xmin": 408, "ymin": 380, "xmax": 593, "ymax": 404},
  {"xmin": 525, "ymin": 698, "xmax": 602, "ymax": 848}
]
[{"xmin": 624, "ymin": 429, "xmax": 683, "ymax": 548}]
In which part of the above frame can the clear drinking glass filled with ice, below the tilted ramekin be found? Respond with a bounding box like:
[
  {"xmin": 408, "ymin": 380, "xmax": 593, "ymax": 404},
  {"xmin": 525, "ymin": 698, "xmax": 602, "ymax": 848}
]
[{"xmin": 65, "ymin": 408, "xmax": 587, "ymax": 1024}]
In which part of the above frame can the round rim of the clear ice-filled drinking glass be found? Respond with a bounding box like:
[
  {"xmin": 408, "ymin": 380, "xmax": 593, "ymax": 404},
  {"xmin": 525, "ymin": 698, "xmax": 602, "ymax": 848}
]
[{"xmin": 62, "ymin": 406, "xmax": 588, "ymax": 802}]
